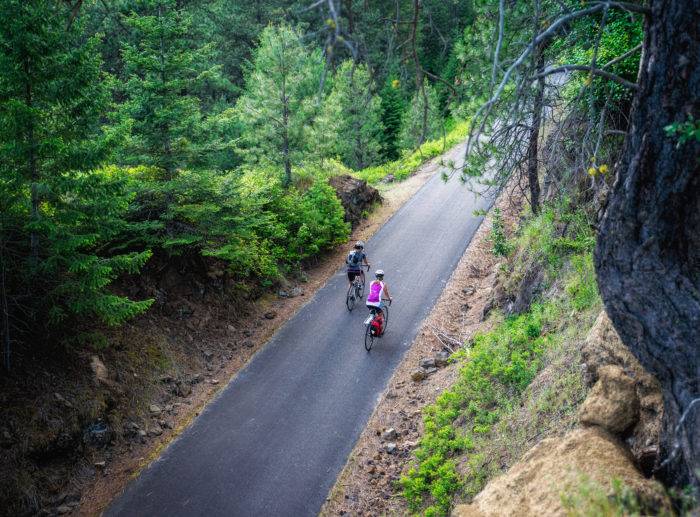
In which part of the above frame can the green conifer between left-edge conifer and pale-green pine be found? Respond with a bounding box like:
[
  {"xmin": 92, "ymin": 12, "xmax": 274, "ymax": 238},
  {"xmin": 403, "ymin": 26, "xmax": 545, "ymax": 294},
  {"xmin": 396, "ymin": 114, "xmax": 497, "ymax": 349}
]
[{"xmin": 117, "ymin": 0, "xmax": 218, "ymax": 179}]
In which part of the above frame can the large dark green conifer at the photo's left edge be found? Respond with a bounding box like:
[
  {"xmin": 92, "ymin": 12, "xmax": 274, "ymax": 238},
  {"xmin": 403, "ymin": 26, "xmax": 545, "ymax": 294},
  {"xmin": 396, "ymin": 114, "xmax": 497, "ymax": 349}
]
[{"xmin": 0, "ymin": 0, "xmax": 148, "ymax": 329}]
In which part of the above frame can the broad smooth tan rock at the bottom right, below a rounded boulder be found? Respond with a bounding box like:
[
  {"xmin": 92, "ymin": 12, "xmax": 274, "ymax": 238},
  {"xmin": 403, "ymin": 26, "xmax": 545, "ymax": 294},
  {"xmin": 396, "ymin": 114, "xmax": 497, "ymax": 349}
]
[{"xmin": 452, "ymin": 427, "xmax": 670, "ymax": 517}]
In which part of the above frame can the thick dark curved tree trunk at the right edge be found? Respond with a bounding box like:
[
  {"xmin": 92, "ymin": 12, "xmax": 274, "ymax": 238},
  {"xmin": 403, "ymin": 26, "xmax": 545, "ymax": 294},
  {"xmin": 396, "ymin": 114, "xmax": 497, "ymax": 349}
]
[{"xmin": 595, "ymin": 0, "xmax": 700, "ymax": 486}]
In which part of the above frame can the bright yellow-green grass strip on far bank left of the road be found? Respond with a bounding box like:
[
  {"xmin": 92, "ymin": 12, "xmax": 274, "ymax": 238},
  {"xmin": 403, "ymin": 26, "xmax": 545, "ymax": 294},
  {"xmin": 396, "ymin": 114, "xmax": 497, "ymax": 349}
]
[{"xmin": 354, "ymin": 121, "xmax": 469, "ymax": 184}]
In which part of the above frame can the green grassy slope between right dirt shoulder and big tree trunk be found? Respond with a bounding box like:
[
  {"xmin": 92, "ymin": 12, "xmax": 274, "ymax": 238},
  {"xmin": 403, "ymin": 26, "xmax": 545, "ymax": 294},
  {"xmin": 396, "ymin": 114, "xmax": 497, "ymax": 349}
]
[{"xmin": 400, "ymin": 206, "xmax": 600, "ymax": 516}]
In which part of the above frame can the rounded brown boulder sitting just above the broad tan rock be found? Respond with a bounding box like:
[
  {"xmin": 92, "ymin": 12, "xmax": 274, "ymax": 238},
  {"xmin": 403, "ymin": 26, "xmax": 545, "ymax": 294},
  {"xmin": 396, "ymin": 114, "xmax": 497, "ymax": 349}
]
[{"xmin": 579, "ymin": 365, "xmax": 639, "ymax": 433}]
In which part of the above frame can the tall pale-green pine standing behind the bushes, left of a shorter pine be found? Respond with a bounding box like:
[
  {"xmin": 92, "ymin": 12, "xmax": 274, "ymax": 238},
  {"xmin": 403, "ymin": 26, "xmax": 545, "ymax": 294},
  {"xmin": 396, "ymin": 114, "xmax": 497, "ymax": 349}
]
[{"xmin": 237, "ymin": 25, "xmax": 323, "ymax": 185}]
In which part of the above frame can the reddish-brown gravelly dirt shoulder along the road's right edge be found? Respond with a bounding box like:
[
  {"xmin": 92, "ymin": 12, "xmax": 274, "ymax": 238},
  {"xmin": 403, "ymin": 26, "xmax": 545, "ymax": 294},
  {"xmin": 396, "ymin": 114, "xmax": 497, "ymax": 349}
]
[{"xmin": 320, "ymin": 183, "xmax": 521, "ymax": 516}]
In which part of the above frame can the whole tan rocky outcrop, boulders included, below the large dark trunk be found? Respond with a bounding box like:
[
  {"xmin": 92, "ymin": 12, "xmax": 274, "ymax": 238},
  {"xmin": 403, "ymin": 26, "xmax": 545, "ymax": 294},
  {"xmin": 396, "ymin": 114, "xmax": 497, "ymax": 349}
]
[{"xmin": 453, "ymin": 312, "xmax": 670, "ymax": 517}]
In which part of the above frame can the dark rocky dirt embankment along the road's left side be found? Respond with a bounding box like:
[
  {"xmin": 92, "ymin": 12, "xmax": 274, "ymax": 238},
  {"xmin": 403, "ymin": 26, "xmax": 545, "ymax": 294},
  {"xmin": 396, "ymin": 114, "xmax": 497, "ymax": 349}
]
[{"xmin": 0, "ymin": 154, "xmax": 446, "ymax": 515}]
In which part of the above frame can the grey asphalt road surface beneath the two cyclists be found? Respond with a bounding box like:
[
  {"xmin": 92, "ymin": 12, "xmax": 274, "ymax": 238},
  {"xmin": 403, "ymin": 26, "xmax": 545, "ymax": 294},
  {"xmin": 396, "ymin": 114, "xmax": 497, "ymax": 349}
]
[{"xmin": 106, "ymin": 146, "xmax": 492, "ymax": 517}]
